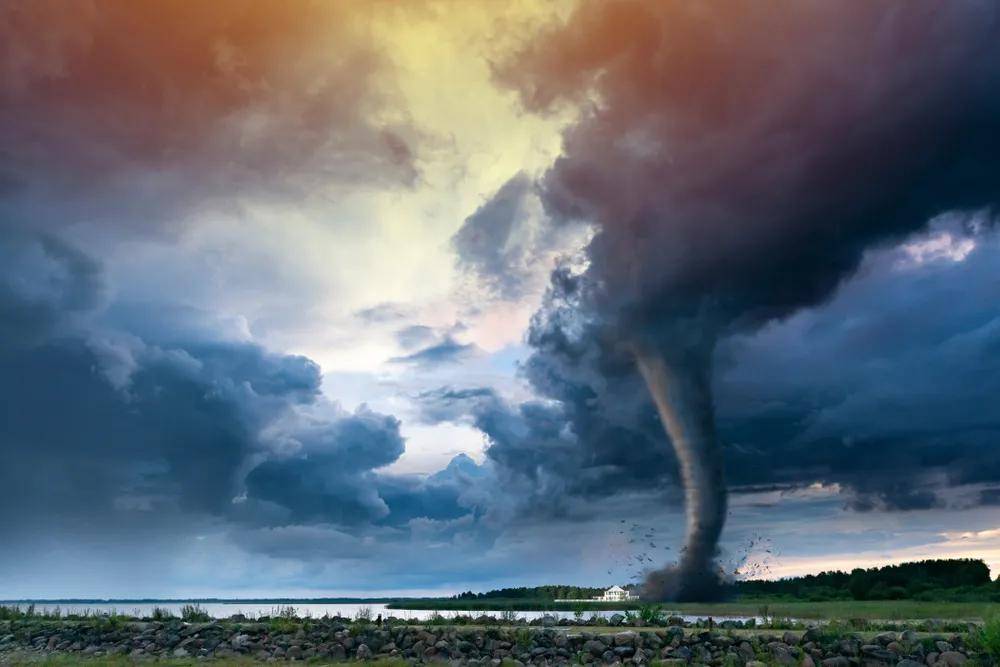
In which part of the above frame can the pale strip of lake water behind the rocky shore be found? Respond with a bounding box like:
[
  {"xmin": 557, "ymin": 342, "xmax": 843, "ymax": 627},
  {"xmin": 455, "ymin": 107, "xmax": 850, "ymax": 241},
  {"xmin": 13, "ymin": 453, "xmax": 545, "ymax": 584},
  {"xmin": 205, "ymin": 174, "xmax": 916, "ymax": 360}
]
[{"xmin": 4, "ymin": 602, "xmax": 751, "ymax": 622}]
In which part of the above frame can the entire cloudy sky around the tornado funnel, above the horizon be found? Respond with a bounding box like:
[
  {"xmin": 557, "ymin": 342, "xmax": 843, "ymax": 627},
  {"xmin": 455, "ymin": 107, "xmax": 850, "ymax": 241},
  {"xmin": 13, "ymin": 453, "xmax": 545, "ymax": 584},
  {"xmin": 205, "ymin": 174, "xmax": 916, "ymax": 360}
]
[{"xmin": 0, "ymin": 0, "xmax": 1000, "ymax": 599}]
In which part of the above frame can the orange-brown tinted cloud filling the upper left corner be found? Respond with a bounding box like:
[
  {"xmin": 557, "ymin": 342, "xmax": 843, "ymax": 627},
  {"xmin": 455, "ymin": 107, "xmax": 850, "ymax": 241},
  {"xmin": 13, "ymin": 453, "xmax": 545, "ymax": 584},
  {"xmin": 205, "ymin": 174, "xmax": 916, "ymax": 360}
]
[{"xmin": 0, "ymin": 0, "xmax": 416, "ymax": 235}]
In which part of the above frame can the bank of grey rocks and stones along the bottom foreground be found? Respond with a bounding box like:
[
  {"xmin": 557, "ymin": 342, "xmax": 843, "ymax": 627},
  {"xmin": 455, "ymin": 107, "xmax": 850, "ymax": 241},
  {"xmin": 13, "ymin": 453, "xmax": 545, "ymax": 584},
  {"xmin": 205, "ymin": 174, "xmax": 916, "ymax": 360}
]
[{"xmin": 0, "ymin": 618, "xmax": 992, "ymax": 667}]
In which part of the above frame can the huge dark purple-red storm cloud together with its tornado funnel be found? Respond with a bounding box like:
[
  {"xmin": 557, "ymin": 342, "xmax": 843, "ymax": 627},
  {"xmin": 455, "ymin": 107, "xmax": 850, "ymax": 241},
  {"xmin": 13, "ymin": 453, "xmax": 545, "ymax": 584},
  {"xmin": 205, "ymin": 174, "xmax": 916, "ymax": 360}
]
[{"xmin": 498, "ymin": 1, "xmax": 1000, "ymax": 599}]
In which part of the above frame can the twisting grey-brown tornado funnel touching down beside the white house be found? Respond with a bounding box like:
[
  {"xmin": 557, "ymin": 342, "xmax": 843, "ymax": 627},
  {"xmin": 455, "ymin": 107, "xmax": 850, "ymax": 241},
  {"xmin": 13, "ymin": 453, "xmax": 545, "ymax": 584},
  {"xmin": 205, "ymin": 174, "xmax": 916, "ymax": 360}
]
[{"xmin": 635, "ymin": 347, "xmax": 726, "ymax": 601}]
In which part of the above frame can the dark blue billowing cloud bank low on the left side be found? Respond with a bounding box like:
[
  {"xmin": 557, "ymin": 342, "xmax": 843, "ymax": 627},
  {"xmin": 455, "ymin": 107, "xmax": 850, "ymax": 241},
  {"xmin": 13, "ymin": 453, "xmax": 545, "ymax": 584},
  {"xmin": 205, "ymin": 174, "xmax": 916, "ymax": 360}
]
[{"xmin": 0, "ymin": 238, "xmax": 478, "ymax": 556}]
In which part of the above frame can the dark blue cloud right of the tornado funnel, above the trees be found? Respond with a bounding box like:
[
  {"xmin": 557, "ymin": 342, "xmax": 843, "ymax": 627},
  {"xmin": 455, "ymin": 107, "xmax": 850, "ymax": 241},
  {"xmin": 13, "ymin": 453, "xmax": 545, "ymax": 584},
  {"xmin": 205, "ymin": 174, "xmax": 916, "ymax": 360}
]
[{"xmin": 718, "ymin": 218, "xmax": 1000, "ymax": 509}]
